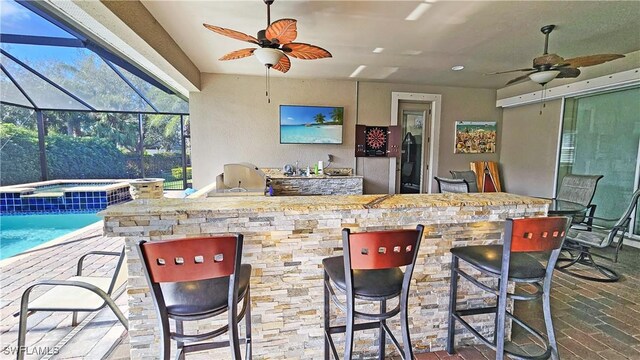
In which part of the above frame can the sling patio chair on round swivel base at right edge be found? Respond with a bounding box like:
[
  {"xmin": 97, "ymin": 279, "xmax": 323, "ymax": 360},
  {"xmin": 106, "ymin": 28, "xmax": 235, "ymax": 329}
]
[{"xmin": 557, "ymin": 189, "xmax": 640, "ymax": 282}]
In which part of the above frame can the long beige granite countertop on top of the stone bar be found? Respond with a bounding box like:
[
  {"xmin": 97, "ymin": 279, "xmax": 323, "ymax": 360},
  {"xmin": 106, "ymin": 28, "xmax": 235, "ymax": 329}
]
[{"xmin": 98, "ymin": 193, "xmax": 550, "ymax": 216}]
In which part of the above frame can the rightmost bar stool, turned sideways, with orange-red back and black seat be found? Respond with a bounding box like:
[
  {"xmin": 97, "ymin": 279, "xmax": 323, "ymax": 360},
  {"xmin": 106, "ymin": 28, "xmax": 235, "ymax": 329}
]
[{"xmin": 447, "ymin": 217, "xmax": 571, "ymax": 360}]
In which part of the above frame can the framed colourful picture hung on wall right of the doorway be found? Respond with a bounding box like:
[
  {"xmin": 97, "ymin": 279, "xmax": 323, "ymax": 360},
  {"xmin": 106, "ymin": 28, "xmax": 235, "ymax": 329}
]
[{"xmin": 454, "ymin": 121, "xmax": 498, "ymax": 154}]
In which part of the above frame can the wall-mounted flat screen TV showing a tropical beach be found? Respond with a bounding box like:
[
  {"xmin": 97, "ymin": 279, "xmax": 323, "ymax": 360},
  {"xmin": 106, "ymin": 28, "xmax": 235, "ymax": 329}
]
[{"xmin": 280, "ymin": 105, "xmax": 344, "ymax": 144}]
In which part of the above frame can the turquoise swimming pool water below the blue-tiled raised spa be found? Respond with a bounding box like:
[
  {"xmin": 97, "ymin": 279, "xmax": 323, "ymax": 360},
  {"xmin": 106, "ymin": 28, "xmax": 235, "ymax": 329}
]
[{"xmin": 0, "ymin": 214, "xmax": 102, "ymax": 259}]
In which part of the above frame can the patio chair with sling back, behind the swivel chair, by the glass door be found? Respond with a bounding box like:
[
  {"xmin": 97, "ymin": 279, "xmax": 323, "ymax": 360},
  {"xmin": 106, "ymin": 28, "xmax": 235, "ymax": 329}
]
[{"xmin": 556, "ymin": 174, "xmax": 603, "ymax": 226}]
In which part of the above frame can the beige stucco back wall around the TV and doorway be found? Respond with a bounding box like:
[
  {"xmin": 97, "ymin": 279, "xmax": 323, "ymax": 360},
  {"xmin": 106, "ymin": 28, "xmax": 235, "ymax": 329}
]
[{"xmin": 190, "ymin": 73, "xmax": 501, "ymax": 193}]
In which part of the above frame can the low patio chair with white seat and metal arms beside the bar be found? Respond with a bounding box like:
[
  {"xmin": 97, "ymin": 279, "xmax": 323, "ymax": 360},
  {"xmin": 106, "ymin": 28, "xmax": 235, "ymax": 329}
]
[{"xmin": 13, "ymin": 247, "xmax": 129, "ymax": 360}]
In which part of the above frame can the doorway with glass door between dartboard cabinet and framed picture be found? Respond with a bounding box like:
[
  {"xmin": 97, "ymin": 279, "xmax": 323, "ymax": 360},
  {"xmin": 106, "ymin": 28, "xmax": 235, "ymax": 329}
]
[{"xmin": 396, "ymin": 101, "xmax": 431, "ymax": 194}]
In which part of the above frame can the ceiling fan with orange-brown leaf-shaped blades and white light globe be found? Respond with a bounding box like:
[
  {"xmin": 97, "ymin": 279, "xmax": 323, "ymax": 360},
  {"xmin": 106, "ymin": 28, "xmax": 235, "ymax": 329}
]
[{"xmin": 202, "ymin": 0, "xmax": 331, "ymax": 73}]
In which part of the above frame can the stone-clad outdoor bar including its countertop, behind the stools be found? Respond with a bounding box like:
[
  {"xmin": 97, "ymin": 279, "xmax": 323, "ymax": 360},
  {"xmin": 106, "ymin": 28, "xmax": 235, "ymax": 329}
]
[{"xmin": 101, "ymin": 193, "xmax": 548, "ymax": 359}]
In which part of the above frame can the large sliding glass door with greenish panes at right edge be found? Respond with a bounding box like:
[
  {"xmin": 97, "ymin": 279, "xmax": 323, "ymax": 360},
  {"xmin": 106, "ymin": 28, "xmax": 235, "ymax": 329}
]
[{"xmin": 558, "ymin": 88, "xmax": 640, "ymax": 234}]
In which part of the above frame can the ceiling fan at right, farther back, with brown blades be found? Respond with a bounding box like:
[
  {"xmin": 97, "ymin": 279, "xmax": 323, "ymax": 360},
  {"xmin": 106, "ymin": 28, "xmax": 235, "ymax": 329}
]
[{"xmin": 487, "ymin": 25, "xmax": 624, "ymax": 86}]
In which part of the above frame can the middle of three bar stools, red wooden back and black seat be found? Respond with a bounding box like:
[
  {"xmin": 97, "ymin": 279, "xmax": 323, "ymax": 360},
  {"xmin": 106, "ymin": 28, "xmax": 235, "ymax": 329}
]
[{"xmin": 322, "ymin": 225, "xmax": 424, "ymax": 360}]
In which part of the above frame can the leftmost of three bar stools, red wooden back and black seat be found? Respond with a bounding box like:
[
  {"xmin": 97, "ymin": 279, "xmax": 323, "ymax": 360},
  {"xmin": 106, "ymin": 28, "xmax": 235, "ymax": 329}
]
[{"xmin": 138, "ymin": 234, "xmax": 251, "ymax": 360}]
